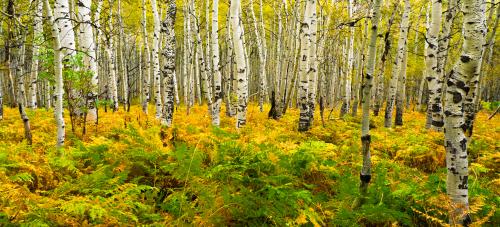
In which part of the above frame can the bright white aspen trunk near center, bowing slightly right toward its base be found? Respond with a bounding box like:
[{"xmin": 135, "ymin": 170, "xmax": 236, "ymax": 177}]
[{"xmin": 230, "ymin": 0, "xmax": 248, "ymax": 128}]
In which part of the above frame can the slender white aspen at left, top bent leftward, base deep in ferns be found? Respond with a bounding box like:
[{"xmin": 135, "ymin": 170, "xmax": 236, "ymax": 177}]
[{"xmin": 45, "ymin": 0, "xmax": 65, "ymax": 148}]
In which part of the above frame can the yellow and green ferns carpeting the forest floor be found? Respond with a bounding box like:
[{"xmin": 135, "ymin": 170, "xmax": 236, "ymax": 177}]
[{"xmin": 0, "ymin": 106, "xmax": 500, "ymax": 226}]
